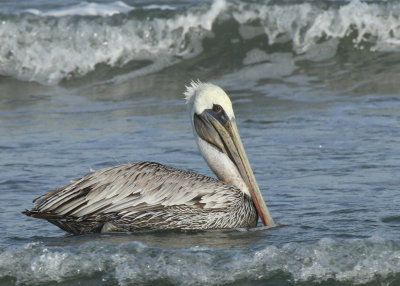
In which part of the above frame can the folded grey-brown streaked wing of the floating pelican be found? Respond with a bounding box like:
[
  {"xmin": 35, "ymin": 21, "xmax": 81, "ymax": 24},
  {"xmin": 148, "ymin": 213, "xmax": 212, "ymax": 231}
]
[{"xmin": 32, "ymin": 162, "xmax": 241, "ymax": 219}]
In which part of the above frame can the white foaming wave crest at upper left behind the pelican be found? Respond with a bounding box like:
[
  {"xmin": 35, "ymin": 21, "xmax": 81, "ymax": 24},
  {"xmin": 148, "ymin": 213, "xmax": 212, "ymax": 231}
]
[{"xmin": 0, "ymin": 0, "xmax": 226, "ymax": 84}]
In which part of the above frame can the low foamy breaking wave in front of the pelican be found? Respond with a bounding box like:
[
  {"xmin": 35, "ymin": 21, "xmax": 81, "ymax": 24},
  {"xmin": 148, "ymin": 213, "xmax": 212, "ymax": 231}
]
[{"xmin": 0, "ymin": 239, "xmax": 400, "ymax": 285}]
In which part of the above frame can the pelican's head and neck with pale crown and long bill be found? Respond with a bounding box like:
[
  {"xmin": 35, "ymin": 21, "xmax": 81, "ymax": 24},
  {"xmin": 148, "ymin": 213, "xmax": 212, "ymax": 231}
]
[{"xmin": 185, "ymin": 81, "xmax": 274, "ymax": 225}]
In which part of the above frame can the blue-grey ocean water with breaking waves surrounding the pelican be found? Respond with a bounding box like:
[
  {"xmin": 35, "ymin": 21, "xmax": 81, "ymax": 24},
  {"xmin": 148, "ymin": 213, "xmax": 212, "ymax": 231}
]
[{"xmin": 0, "ymin": 0, "xmax": 400, "ymax": 285}]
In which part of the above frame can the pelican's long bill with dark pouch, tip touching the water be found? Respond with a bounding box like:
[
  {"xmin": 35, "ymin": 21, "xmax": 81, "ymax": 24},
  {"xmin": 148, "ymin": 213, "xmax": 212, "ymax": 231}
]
[{"xmin": 193, "ymin": 109, "xmax": 275, "ymax": 226}]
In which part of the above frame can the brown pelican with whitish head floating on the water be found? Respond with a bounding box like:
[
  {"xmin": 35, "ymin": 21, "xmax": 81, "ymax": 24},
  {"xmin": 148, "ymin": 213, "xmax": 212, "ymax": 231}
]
[{"xmin": 24, "ymin": 81, "xmax": 274, "ymax": 234}]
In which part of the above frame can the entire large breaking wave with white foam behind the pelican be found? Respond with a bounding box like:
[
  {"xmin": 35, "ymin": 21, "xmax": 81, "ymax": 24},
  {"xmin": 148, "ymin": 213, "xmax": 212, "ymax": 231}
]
[{"xmin": 0, "ymin": 0, "xmax": 400, "ymax": 84}]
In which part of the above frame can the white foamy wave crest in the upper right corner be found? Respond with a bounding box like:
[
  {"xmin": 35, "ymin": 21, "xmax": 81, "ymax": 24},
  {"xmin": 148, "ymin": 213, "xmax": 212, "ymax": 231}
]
[{"xmin": 233, "ymin": 0, "xmax": 400, "ymax": 53}]
